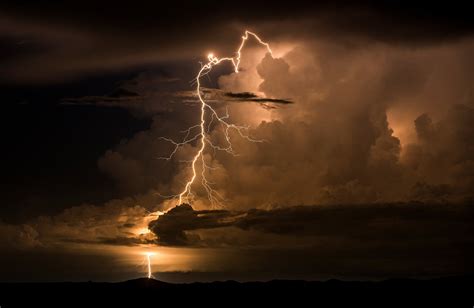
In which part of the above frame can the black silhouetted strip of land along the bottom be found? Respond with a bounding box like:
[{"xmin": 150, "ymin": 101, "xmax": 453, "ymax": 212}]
[{"xmin": 0, "ymin": 276, "xmax": 474, "ymax": 308}]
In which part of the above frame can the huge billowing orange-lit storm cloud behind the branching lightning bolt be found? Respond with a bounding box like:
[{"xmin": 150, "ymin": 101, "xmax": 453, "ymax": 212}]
[{"xmin": 86, "ymin": 34, "xmax": 474, "ymax": 210}]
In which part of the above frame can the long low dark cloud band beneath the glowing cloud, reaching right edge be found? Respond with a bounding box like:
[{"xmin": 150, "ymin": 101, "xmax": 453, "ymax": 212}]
[{"xmin": 149, "ymin": 202, "xmax": 474, "ymax": 248}]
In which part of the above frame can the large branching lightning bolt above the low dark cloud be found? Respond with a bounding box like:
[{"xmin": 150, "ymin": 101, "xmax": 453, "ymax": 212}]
[{"xmin": 160, "ymin": 30, "xmax": 273, "ymax": 207}]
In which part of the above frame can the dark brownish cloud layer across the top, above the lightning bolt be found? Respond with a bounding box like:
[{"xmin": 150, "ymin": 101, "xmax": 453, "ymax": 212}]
[{"xmin": 0, "ymin": 1, "xmax": 474, "ymax": 82}]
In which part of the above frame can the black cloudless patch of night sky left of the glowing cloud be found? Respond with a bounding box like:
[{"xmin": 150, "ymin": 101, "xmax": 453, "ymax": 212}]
[{"xmin": 2, "ymin": 76, "xmax": 144, "ymax": 220}]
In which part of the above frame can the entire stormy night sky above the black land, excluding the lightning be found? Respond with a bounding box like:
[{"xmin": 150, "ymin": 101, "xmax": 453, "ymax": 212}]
[{"xmin": 0, "ymin": 1, "xmax": 474, "ymax": 282}]
